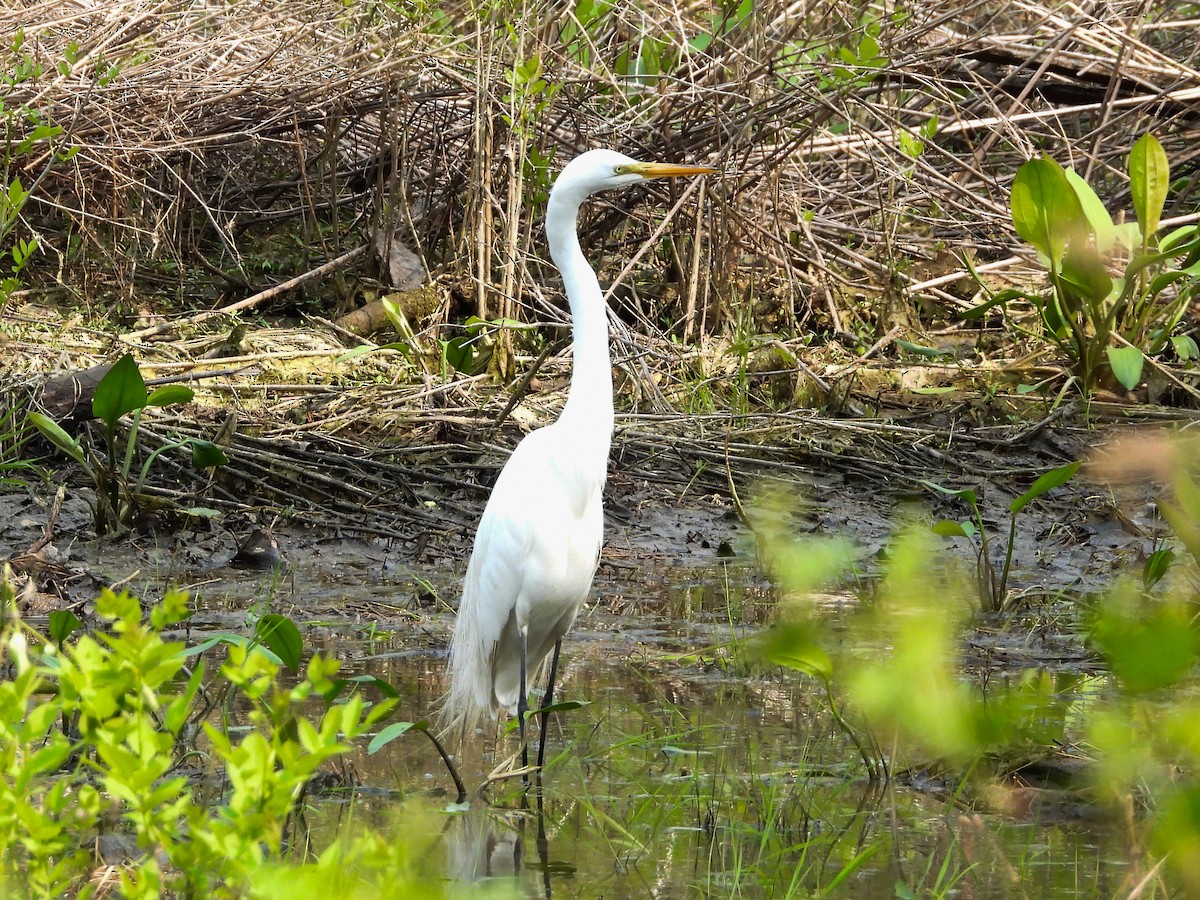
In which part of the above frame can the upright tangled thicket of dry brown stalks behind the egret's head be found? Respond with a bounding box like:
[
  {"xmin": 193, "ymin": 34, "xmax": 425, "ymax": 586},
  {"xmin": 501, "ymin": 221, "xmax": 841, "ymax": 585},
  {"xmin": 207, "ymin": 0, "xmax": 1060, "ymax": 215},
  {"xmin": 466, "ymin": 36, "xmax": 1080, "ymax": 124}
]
[{"xmin": 7, "ymin": 0, "xmax": 1200, "ymax": 338}]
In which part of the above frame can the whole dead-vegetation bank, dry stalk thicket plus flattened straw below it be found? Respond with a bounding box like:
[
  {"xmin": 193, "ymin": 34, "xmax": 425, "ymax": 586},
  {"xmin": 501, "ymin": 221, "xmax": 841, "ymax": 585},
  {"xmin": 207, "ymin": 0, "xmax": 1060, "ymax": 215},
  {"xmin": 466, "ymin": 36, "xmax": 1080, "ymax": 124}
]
[{"xmin": 0, "ymin": 0, "xmax": 1200, "ymax": 532}]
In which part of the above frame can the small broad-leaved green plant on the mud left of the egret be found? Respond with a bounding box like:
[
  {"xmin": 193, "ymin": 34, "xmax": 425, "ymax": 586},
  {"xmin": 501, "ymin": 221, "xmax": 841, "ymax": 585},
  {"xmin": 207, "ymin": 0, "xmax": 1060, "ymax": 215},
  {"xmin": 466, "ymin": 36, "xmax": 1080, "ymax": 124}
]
[{"xmin": 29, "ymin": 353, "xmax": 229, "ymax": 534}]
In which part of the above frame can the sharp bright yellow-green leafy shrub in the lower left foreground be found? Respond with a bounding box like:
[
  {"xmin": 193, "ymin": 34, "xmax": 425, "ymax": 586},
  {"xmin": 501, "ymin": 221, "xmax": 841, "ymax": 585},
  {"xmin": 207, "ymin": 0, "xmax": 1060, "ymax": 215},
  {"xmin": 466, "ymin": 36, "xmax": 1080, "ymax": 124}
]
[{"xmin": 0, "ymin": 580, "xmax": 403, "ymax": 896}]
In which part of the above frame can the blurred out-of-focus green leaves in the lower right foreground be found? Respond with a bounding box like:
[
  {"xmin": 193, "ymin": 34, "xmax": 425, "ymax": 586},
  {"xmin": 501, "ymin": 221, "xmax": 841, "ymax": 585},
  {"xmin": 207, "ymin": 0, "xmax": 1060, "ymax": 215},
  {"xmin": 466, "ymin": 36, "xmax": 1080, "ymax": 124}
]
[{"xmin": 754, "ymin": 434, "xmax": 1200, "ymax": 890}]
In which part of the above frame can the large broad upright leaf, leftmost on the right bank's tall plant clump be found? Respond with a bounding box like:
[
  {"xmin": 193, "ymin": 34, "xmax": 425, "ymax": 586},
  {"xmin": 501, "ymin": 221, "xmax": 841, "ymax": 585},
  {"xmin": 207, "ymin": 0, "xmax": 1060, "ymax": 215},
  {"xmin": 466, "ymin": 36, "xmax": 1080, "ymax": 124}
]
[{"xmin": 1012, "ymin": 157, "xmax": 1087, "ymax": 268}]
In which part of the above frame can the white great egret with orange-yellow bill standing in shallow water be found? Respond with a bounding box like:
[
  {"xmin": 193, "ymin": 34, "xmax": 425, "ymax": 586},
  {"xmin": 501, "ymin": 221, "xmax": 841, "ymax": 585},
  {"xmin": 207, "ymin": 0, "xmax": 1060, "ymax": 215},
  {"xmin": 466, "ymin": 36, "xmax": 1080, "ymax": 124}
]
[{"xmin": 442, "ymin": 150, "xmax": 715, "ymax": 768}]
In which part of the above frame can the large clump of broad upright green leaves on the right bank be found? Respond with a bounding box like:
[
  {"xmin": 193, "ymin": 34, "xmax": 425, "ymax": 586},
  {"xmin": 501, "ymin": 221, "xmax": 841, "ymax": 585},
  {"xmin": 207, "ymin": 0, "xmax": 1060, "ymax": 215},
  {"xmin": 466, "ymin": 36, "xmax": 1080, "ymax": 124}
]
[{"xmin": 966, "ymin": 134, "xmax": 1200, "ymax": 392}]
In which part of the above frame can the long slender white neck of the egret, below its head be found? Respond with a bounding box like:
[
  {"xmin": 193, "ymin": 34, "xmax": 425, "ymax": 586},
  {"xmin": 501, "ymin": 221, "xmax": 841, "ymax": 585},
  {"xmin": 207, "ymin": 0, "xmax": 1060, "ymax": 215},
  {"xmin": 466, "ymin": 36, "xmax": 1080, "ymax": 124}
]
[{"xmin": 546, "ymin": 188, "xmax": 613, "ymax": 451}]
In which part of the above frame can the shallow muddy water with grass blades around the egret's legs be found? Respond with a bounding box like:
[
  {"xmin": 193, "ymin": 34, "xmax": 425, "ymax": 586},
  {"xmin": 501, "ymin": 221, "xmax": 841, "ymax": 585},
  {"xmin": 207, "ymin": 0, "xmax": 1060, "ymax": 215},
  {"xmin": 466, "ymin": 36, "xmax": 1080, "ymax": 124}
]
[{"xmin": 2, "ymin": 482, "xmax": 1161, "ymax": 898}]
